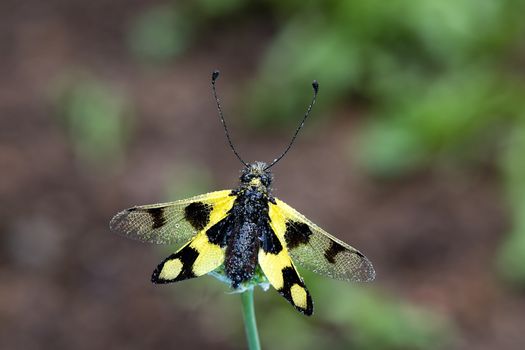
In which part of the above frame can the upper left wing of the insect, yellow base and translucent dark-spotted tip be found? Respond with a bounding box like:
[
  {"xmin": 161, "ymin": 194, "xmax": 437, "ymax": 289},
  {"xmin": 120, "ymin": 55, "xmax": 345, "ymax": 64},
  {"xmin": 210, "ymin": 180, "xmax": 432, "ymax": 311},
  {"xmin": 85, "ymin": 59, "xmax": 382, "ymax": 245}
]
[{"xmin": 109, "ymin": 190, "xmax": 235, "ymax": 244}]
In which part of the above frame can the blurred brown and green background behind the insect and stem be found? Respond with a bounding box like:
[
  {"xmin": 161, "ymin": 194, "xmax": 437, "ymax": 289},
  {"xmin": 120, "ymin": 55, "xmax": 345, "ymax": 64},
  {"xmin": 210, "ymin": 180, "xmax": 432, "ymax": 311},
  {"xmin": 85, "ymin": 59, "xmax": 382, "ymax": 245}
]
[{"xmin": 0, "ymin": 0, "xmax": 525, "ymax": 350}]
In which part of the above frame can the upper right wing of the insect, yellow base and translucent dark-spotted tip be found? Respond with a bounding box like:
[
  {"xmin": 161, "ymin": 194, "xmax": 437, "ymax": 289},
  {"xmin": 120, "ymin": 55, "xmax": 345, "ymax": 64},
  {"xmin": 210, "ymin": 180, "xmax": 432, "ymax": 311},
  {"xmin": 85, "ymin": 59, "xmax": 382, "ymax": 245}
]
[{"xmin": 269, "ymin": 199, "xmax": 375, "ymax": 282}]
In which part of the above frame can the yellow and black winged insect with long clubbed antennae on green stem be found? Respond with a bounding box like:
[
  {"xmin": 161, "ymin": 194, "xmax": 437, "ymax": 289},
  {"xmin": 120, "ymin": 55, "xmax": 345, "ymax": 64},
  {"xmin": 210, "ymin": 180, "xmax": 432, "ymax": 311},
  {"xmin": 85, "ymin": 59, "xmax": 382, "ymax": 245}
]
[{"xmin": 110, "ymin": 71, "xmax": 375, "ymax": 315}]
